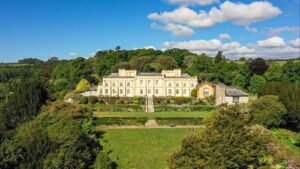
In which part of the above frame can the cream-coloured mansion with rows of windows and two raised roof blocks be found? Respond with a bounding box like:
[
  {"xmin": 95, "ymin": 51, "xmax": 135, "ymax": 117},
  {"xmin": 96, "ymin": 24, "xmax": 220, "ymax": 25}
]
[{"xmin": 97, "ymin": 69, "xmax": 198, "ymax": 97}]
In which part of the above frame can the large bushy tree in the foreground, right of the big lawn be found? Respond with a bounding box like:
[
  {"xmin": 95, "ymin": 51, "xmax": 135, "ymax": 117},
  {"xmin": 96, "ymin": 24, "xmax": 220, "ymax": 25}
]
[{"xmin": 168, "ymin": 106, "xmax": 267, "ymax": 169}]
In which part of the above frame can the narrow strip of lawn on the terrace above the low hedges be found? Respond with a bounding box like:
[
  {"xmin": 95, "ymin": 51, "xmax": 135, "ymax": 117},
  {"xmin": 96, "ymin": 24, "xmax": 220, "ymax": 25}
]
[{"xmin": 94, "ymin": 111, "xmax": 212, "ymax": 117}]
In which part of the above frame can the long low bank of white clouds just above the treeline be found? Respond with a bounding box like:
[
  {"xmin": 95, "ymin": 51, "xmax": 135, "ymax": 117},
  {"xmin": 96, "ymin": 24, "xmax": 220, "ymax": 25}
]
[{"xmin": 163, "ymin": 37, "xmax": 300, "ymax": 59}]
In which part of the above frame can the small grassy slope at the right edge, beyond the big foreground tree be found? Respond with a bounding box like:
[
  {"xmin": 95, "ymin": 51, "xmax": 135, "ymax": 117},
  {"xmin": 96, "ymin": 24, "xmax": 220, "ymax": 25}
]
[{"xmin": 272, "ymin": 129, "xmax": 300, "ymax": 156}]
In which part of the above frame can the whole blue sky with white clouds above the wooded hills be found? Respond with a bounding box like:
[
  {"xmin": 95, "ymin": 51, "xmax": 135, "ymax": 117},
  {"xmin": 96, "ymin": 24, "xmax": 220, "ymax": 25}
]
[{"xmin": 0, "ymin": 0, "xmax": 300, "ymax": 62}]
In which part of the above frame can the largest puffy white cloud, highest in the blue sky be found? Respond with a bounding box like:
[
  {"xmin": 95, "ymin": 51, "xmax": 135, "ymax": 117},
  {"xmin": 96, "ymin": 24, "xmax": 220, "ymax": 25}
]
[{"xmin": 148, "ymin": 1, "xmax": 281, "ymax": 36}]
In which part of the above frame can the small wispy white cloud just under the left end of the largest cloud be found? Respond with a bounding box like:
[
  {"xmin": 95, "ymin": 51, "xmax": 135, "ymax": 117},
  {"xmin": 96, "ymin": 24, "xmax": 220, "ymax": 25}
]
[{"xmin": 151, "ymin": 23, "xmax": 194, "ymax": 37}]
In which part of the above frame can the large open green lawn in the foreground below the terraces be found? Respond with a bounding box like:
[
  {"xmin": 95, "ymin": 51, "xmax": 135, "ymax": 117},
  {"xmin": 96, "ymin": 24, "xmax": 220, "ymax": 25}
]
[{"xmin": 101, "ymin": 128, "xmax": 201, "ymax": 169}]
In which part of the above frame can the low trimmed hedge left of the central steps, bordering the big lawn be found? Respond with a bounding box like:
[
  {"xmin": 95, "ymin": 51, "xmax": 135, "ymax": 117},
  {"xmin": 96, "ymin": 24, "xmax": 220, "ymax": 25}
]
[{"xmin": 95, "ymin": 117, "xmax": 148, "ymax": 126}]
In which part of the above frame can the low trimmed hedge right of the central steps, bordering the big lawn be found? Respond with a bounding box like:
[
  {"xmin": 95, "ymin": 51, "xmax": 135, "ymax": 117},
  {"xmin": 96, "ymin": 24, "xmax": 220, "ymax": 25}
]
[{"xmin": 155, "ymin": 117, "xmax": 204, "ymax": 126}]
